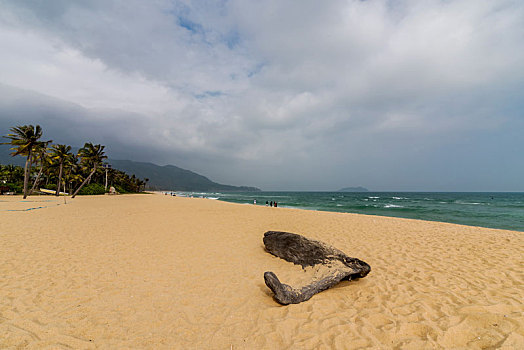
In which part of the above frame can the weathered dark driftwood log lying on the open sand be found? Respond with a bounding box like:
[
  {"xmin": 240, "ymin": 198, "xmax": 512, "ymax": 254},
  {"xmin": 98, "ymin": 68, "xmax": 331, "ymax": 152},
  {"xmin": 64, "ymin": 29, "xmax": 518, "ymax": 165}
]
[{"xmin": 264, "ymin": 231, "xmax": 371, "ymax": 305}]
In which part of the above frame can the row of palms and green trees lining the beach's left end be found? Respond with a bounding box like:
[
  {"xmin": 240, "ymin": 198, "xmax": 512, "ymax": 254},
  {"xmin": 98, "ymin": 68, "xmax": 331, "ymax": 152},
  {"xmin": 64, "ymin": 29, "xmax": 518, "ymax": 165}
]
[{"xmin": 0, "ymin": 125, "xmax": 148, "ymax": 199}]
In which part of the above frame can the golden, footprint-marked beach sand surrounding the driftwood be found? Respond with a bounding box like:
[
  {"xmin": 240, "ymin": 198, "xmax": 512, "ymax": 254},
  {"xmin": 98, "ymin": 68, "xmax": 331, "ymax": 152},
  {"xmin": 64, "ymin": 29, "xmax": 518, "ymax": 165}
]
[{"xmin": 0, "ymin": 195, "xmax": 524, "ymax": 349}]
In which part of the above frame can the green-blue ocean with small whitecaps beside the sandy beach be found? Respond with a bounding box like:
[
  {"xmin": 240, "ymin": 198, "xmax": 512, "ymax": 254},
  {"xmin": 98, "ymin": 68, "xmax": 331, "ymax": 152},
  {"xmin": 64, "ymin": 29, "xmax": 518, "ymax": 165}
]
[{"xmin": 179, "ymin": 192, "xmax": 524, "ymax": 231}]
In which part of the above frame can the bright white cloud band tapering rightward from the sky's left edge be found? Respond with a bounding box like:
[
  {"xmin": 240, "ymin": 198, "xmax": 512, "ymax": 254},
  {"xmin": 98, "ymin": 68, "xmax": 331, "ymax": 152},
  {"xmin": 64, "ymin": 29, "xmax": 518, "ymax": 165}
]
[{"xmin": 0, "ymin": 22, "xmax": 182, "ymax": 114}]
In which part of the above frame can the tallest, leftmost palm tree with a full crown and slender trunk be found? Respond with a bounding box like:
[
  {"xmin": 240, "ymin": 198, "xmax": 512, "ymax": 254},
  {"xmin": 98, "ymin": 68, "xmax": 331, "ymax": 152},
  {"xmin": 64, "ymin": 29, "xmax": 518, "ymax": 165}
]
[{"xmin": 3, "ymin": 125, "xmax": 48, "ymax": 199}]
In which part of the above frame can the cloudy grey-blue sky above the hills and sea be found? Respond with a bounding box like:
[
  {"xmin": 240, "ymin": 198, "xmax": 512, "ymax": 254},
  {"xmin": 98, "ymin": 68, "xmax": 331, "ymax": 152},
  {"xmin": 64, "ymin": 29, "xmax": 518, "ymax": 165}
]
[{"xmin": 0, "ymin": 0, "xmax": 524, "ymax": 191}]
